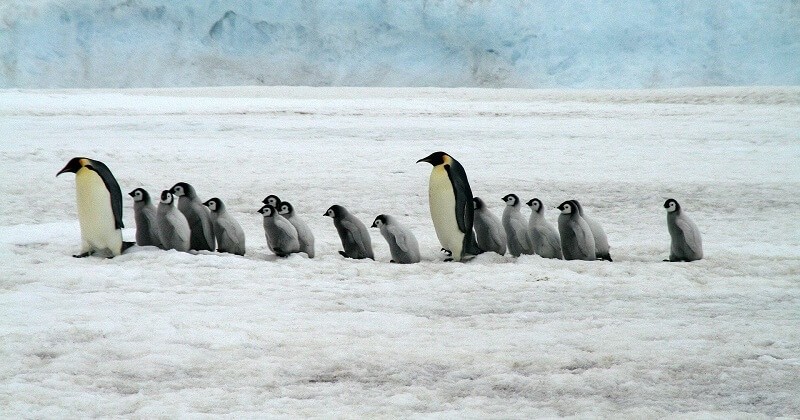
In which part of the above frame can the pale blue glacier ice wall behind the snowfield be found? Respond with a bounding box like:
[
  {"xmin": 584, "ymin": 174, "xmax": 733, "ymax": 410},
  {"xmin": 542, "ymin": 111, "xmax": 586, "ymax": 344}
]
[{"xmin": 0, "ymin": 0, "xmax": 800, "ymax": 88}]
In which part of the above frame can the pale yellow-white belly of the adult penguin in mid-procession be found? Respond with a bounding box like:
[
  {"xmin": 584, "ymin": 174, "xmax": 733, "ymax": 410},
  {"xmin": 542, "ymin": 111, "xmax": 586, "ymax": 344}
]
[{"xmin": 428, "ymin": 166, "xmax": 464, "ymax": 261}]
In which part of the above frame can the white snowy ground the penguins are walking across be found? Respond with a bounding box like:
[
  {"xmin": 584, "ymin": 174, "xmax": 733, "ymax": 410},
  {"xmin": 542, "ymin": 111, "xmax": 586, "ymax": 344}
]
[{"xmin": 0, "ymin": 88, "xmax": 800, "ymax": 418}]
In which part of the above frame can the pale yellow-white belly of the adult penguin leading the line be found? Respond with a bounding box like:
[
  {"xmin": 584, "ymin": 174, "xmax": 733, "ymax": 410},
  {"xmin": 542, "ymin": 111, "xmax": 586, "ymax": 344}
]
[{"xmin": 75, "ymin": 168, "xmax": 122, "ymax": 255}]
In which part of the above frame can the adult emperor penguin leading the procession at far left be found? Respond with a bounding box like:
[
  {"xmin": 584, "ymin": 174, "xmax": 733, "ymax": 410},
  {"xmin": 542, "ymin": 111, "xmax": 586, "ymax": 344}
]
[{"xmin": 56, "ymin": 157, "xmax": 133, "ymax": 258}]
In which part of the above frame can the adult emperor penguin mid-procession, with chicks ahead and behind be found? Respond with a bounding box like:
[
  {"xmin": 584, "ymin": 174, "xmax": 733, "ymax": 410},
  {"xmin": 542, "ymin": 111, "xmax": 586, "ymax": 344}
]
[{"xmin": 417, "ymin": 152, "xmax": 483, "ymax": 261}]
